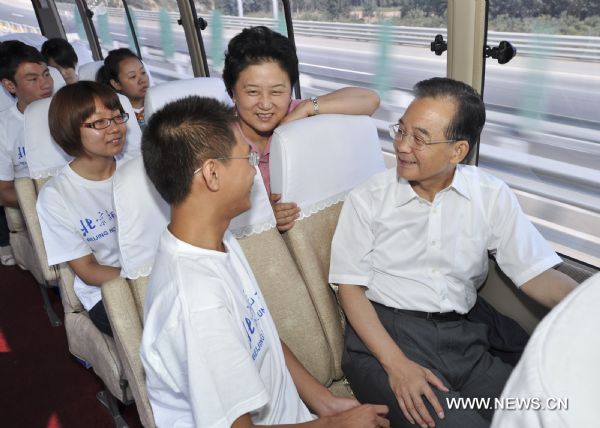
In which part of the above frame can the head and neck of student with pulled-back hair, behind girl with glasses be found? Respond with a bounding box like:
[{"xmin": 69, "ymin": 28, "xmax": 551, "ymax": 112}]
[{"xmin": 96, "ymin": 48, "xmax": 150, "ymax": 129}]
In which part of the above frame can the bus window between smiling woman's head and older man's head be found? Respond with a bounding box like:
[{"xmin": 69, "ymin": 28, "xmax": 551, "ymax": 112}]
[{"xmin": 288, "ymin": 0, "xmax": 447, "ymax": 157}]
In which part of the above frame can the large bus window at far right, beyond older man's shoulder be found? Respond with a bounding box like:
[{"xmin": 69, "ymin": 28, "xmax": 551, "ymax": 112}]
[{"xmin": 479, "ymin": 1, "xmax": 600, "ymax": 266}]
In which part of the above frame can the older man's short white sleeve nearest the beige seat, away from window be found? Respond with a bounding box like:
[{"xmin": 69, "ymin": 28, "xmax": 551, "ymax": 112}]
[{"xmin": 329, "ymin": 193, "xmax": 374, "ymax": 287}]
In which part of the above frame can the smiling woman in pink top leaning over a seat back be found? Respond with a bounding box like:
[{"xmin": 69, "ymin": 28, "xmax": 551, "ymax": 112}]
[{"xmin": 223, "ymin": 26, "xmax": 379, "ymax": 232}]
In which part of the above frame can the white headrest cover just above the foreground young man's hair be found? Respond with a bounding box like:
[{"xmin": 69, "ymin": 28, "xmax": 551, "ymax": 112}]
[{"xmin": 144, "ymin": 77, "xmax": 233, "ymax": 122}]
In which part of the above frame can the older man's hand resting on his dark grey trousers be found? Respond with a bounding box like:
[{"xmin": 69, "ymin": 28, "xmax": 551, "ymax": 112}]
[{"xmin": 386, "ymin": 359, "xmax": 448, "ymax": 427}]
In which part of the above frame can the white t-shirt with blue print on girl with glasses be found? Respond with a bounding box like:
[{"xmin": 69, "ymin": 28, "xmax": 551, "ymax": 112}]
[{"xmin": 37, "ymin": 165, "xmax": 120, "ymax": 310}]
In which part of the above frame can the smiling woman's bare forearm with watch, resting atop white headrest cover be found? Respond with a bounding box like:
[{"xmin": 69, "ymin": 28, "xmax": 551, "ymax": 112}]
[{"xmin": 280, "ymin": 87, "xmax": 379, "ymax": 124}]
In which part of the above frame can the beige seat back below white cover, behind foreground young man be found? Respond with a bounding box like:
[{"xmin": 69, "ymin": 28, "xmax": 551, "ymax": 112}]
[{"xmin": 102, "ymin": 276, "xmax": 156, "ymax": 428}]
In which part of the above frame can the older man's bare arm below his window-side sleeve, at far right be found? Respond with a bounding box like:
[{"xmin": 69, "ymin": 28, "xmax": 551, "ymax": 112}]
[{"xmin": 521, "ymin": 268, "xmax": 577, "ymax": 308}]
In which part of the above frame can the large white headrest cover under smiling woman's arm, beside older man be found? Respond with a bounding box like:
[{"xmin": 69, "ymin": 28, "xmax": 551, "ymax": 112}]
[{"xmin": 270, "ymin": 114, "xmax": 385, "ymax": 218}]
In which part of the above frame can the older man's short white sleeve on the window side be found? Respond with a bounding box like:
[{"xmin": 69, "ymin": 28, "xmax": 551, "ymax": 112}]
[{"xmin": 488, "ymin": 183, "xmax": 562, "ymax": 287}]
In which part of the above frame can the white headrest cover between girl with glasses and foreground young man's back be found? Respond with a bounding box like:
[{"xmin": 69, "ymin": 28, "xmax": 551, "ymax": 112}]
[{"xmin": 113, "ymin": 156, "xmax": 171, "ymax": 279}]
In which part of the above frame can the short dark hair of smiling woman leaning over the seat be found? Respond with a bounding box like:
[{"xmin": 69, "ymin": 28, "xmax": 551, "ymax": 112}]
[{"xmin": 223, "ymin": 26, "xmax": 299, "ymax": 97}]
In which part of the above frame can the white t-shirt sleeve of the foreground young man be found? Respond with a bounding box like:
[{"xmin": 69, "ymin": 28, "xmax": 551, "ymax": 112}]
[{"xmin": 154, "ymin": 288, "xmax": 269, "ymax": 427}]
